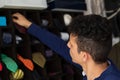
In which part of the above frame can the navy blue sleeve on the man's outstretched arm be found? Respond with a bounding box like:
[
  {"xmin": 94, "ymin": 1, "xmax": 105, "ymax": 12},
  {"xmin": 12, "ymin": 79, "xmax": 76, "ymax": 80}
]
[{"xmin": 27, "ymin": 24, "xmax": 82, "ymax": 69}]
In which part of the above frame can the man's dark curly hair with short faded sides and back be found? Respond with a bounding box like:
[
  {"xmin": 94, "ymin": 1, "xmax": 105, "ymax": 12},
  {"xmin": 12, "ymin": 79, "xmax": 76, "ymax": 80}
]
[{"xmin": 68, "ymin": 14, "xmax": 112, "ymax": 63}]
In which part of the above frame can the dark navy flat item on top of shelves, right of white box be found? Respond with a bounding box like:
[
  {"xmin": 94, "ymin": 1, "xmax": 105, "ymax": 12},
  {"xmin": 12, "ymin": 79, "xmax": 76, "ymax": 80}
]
[{"xmin": 48, "ymin": 0, "xmax": 87, "ymax": 12}]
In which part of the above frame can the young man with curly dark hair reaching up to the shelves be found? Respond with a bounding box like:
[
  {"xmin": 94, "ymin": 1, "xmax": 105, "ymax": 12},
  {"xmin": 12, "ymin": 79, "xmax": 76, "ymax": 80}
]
[{"xmin": 12, "ymin": 13, "xmax": 120, "ymax": 80}]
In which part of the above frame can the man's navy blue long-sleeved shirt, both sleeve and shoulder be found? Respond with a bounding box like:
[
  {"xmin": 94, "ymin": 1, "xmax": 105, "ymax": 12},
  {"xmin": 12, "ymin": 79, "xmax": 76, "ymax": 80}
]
[{"xmin": 27, "ymin": 23, "xmax": 120, "ymax": 80}]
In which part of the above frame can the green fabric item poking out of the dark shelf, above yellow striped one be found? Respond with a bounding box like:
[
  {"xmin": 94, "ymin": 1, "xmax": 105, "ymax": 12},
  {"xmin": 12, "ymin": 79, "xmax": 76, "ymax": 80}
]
[{"xmin": 1, "ymin": 54, "xmax": 18, "ymax": 72}]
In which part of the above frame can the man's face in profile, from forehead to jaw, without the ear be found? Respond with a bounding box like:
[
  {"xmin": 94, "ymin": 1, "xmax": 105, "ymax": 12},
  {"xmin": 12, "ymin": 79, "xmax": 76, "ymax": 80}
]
[{"xmin": 67, "ymin": 34, "xmax": 80, "ymax": 64}]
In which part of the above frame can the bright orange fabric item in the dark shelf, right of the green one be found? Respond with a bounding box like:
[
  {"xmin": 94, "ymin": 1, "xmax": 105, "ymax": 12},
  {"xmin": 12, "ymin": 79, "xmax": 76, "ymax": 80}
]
[{"xmin": 17, "ymin": 54, "xmax": 34, "ymax": 71}]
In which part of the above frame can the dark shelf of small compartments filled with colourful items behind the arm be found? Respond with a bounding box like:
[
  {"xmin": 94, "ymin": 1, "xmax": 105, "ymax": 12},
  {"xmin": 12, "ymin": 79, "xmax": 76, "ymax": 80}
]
[{"xmin": 0, "ymin": 9, "xmax": 82, "ymax": 80}]
